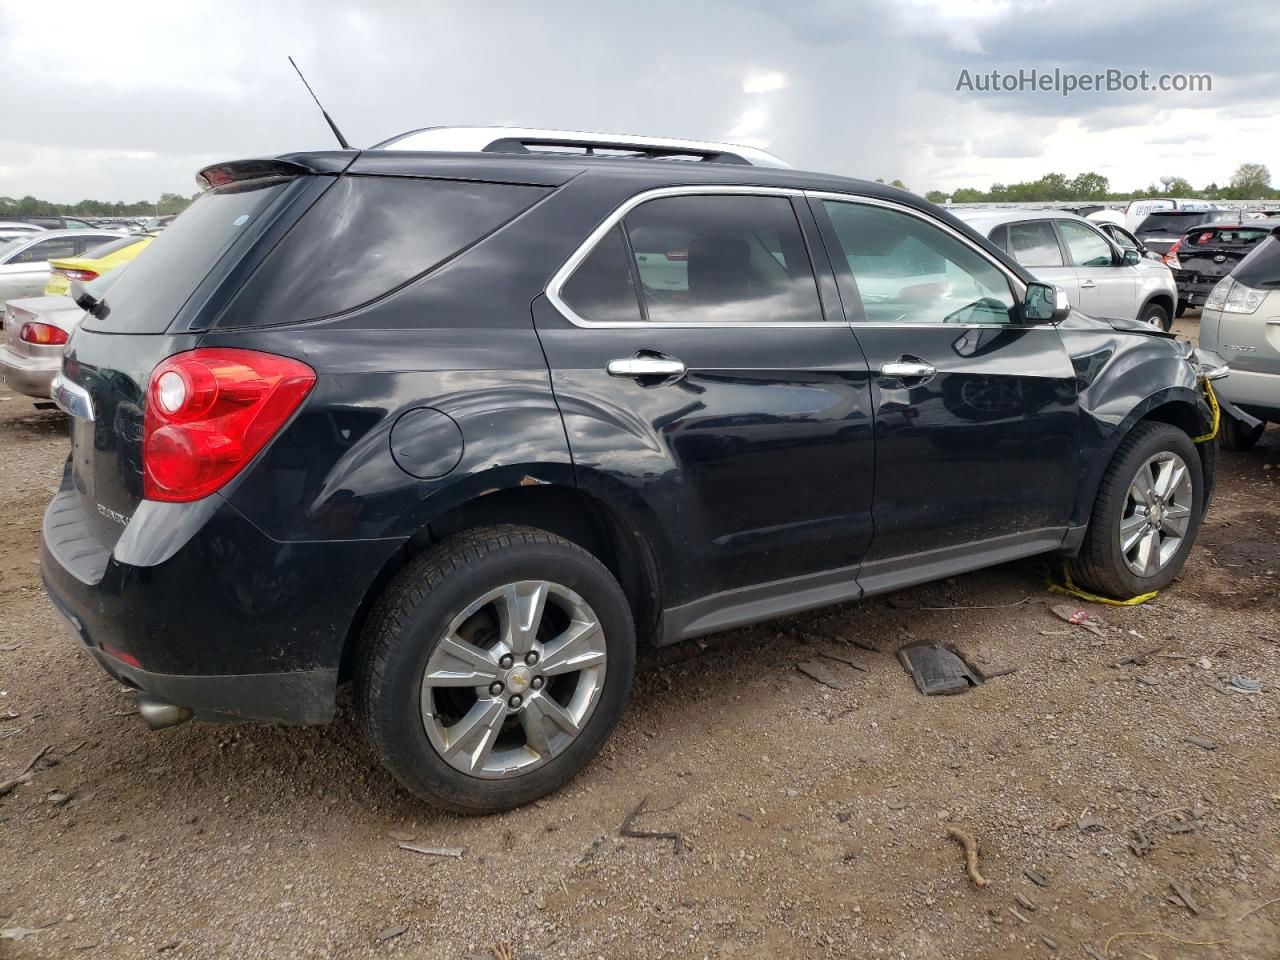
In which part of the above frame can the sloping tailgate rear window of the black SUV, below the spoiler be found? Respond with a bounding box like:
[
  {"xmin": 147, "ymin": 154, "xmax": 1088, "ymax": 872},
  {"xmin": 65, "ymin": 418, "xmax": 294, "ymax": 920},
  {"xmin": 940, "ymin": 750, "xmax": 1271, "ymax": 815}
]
[{"xmin": 84, "ymin": 179, "xmax": 287, "ymax": 333}]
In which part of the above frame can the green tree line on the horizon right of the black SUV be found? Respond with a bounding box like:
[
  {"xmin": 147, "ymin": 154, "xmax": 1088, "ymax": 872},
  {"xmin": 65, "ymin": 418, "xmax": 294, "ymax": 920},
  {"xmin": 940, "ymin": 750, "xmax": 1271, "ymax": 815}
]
[{"xmin": 879, "ymin": 164, "xmax": 1280, "ymax": 204}]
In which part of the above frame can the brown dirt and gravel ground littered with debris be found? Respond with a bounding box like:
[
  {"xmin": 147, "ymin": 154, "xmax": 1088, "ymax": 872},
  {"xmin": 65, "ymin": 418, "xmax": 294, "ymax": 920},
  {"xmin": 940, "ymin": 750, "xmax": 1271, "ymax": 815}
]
[{"xmin": 0, "ymin": 317, "xmax": 1280, "ymax": 960}]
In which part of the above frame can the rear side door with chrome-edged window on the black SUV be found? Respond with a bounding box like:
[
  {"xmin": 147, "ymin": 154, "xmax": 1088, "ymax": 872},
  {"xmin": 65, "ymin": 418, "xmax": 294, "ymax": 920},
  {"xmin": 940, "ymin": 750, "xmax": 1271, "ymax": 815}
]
[{"xmin": 534, "ymin": 187, "xmax": 874, "ymax": 616}]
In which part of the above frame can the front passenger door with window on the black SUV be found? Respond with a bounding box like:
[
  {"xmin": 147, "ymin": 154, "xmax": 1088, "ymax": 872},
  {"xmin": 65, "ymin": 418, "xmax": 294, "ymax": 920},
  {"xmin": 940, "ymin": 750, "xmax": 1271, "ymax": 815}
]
[{"xmin": 812, "ymin": 195, "xmax": 1078, "ymax": 591}]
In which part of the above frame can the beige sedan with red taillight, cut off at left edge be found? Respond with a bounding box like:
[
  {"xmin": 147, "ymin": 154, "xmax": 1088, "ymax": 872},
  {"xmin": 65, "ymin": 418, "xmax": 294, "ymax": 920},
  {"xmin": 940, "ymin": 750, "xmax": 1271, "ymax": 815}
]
[{"xmin": 0, "ymin": 296, "xmax": 84, "ymax": 399}]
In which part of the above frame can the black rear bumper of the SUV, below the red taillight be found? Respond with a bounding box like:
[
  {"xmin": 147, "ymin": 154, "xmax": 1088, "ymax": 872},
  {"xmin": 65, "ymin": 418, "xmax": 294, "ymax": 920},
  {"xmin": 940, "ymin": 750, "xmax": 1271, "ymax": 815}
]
[{"xmin": 41, "ymin": 479, "xmax": 399, "ymax": 724}]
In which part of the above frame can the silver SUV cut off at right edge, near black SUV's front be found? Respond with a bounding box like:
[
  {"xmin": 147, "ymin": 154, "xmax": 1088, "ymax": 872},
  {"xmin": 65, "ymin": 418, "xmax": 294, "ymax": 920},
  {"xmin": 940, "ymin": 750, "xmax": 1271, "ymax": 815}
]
[{"xmin": 1199, "ymin": 227, "xmax": 1280, "ymax": 451}]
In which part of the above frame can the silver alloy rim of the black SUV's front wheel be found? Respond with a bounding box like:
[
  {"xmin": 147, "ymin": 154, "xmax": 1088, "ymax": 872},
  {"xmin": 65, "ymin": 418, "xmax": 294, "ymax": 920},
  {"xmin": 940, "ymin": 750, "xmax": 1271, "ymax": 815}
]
[{"xmin": 1120, "ymin": 451, "xmax": 1192, "ymax": 577}]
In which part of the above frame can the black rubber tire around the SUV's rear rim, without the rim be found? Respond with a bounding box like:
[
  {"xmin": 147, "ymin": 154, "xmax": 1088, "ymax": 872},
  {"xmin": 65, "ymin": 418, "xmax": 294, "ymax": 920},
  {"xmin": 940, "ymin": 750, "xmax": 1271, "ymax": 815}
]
[{"xmin": 355, "ymin": 526, "xmax": 635, "ymax": 814}]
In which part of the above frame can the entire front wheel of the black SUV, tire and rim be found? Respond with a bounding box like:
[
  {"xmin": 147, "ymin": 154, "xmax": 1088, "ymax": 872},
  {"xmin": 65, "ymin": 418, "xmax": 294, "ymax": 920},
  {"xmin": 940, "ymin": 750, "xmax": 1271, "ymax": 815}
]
[{"xmin": 1070, "ymin": 422, "xmax": 1204, "ymax": 599}]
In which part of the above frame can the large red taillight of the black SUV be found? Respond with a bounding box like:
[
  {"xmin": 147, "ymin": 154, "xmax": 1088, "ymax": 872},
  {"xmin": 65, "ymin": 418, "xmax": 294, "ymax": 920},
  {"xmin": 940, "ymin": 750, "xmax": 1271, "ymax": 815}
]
[{"xmin": 142, "ymin": 348, "xmax": 316, "ymax": 502}]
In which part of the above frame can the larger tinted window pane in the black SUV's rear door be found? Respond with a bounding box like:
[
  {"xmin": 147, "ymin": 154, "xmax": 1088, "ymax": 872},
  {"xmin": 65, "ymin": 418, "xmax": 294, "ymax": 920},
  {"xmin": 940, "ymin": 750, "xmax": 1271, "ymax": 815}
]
[{"xmin": 623, "ymin": 196, "xmax": 823, "ymax": 323}]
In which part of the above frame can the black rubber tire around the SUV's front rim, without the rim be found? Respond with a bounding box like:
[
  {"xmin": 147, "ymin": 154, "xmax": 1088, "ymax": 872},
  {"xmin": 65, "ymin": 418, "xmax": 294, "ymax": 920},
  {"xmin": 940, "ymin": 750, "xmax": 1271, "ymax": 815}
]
[{"xmin": 1069, "ymin": 422, "xmax": 1204, "ymax": 600}]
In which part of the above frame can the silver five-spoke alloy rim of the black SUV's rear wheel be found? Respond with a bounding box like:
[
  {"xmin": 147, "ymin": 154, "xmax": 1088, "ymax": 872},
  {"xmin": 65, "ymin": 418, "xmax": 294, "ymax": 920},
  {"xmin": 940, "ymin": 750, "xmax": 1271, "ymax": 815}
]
[{"xmin": 421, "ymin": 580, "xmax": 605, "ymax": 780}]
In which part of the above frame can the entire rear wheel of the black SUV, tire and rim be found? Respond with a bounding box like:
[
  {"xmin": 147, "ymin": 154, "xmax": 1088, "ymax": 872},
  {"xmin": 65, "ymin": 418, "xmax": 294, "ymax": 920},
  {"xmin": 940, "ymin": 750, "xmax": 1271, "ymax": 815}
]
[{"xmin": 356, "ymin": 526, "xmax": 635, "ymax": 813}]
